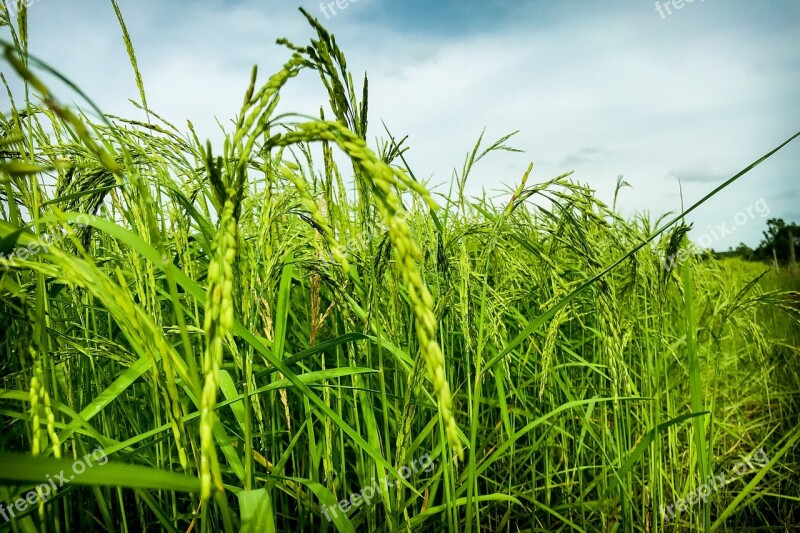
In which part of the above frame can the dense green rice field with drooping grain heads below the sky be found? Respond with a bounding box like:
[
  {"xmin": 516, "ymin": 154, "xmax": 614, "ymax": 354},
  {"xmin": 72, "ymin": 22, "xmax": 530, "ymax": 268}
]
[{"xmin": 0, "ymin": 6, "xmax": 800, "ymax": 532}]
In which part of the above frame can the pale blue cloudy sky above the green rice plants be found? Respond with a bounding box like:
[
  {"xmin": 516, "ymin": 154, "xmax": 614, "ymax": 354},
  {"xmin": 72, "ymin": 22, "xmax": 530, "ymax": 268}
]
[{"xmin": 0, "ymin": 0, "xmax": 800, "ymax": 250}]
